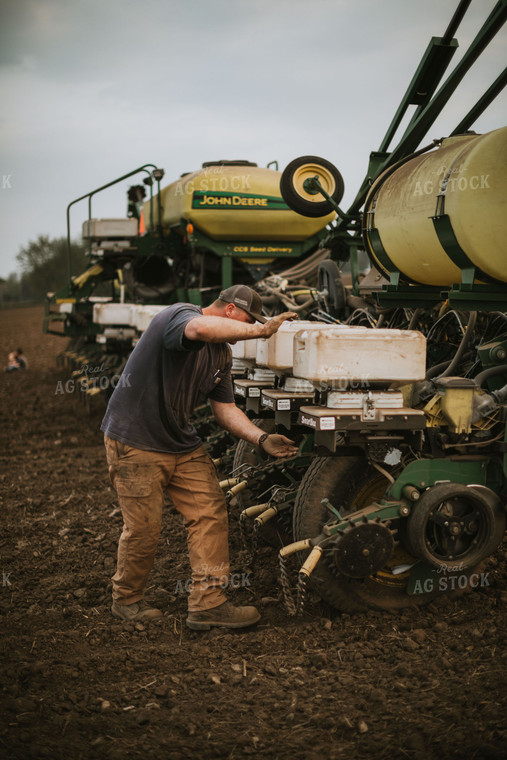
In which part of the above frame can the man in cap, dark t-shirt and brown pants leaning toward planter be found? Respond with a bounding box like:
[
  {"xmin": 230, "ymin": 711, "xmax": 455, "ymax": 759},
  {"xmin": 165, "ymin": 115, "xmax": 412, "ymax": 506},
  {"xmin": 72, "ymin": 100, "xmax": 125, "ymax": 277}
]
[{"xmin": 101, "ymin": 285, "xmax": 297, "ymax": 630}]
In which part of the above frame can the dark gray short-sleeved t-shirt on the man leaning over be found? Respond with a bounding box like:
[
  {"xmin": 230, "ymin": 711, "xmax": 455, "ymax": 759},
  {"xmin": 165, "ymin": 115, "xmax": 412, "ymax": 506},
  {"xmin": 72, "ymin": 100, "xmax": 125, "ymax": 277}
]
[{"xmin": 101, "ymin": 304, "xmax": 234, "ymax": 454}]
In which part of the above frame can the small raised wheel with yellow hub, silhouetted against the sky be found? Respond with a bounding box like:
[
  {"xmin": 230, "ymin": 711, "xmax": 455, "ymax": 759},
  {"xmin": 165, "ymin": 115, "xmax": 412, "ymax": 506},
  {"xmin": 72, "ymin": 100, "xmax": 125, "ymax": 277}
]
[{"xmin": 280, "ymin": 156, "xmax": 344, "ymax": 217}]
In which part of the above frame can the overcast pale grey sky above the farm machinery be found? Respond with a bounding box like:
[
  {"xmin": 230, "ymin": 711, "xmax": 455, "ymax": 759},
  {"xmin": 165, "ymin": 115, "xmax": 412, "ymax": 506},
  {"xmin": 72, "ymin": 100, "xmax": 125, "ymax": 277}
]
[{"xmin": 0, "ymin": 0, "xmax": 507, "ymax": 284}]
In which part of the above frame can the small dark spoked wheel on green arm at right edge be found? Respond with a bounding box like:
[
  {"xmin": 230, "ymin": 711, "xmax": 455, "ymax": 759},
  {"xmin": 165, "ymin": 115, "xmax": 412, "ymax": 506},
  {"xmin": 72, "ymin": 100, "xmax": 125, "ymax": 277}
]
[{"xmin": 407, "ymin": 483, "xmax": 505, "ymax": 570}]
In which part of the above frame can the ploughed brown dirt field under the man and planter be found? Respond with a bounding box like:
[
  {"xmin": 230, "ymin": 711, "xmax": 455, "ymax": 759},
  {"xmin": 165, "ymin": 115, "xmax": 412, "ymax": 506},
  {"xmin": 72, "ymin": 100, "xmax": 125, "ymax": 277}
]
[{"xmin": 0, "ymin": 308, "xmax": 507, "ymax": 760}]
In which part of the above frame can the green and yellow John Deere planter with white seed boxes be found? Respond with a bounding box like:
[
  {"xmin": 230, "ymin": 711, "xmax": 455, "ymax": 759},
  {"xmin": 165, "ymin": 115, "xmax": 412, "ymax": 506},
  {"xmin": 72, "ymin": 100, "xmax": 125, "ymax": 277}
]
[{"xmin": 45, "ymin": 0, "xmax": 507, "ymax": 614}]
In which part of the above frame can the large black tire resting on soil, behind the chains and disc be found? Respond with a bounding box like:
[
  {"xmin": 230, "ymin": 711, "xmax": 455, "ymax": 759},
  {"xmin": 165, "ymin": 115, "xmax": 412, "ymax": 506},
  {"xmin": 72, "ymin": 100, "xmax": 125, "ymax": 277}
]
[{"xmin": 293, "ymin": 457, "xmax": 492, "ymax": 612}]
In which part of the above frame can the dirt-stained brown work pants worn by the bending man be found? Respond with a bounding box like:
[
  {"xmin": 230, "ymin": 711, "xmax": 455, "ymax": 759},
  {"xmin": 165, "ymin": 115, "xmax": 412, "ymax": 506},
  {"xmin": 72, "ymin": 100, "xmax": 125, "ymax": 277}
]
[{"xmin": 104, "ymin": 436, "xmax": 229, "ymax": 612}]
